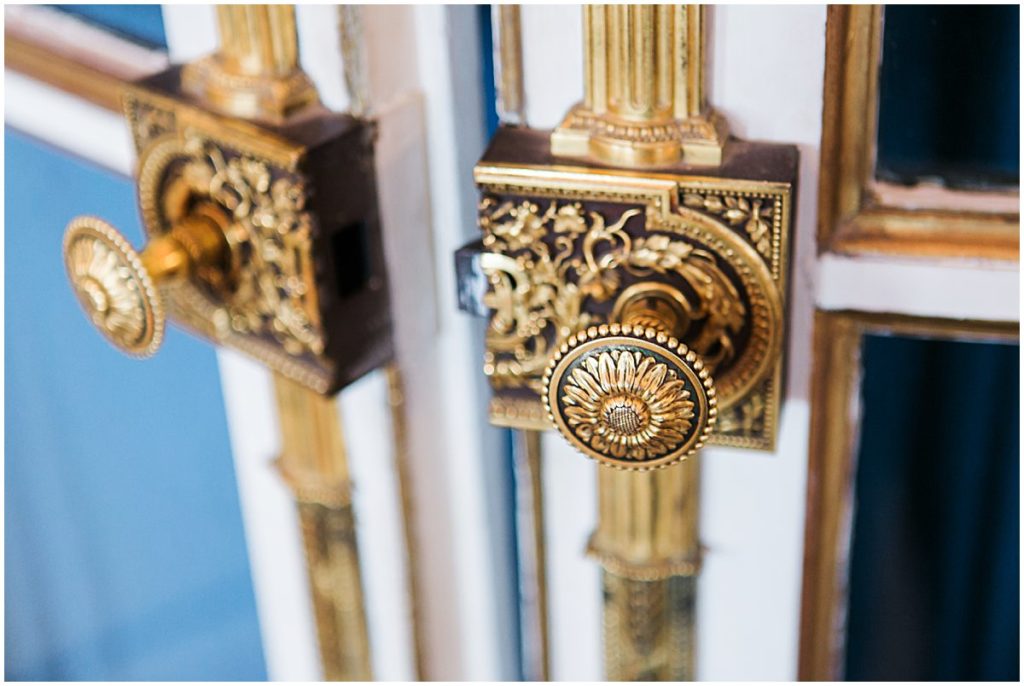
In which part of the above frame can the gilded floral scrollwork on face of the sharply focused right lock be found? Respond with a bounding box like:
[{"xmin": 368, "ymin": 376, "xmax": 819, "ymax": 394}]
[{"xmin": 479, "ymin": 197, "xmax": 745, "ymax": 393}]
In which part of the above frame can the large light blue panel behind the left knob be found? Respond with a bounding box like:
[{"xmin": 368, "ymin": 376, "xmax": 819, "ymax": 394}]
[{"xmin": 4, "ymin": 129, "xmax": 266, "ymax": 680}]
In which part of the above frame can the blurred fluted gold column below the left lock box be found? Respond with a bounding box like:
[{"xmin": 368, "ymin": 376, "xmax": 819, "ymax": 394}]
[{"xmin": 274, "ymin": 375, "xmax": 373, "ymax": 681}]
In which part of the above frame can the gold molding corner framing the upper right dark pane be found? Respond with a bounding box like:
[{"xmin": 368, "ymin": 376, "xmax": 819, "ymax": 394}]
[{"xmin": 817, "ymin": 5, "xmax": 1020, "ymax": 261}]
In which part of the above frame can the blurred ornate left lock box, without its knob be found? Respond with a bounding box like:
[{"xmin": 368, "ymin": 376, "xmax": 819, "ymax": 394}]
[{"xmin": 124, "ymin": 68, "xmax": 392, "ymax": 393}]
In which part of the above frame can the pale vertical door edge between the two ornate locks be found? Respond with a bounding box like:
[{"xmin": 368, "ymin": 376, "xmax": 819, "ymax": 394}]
[{"xmin": 385, "ymin": 5, "xmax": 516, "ymax": 681}]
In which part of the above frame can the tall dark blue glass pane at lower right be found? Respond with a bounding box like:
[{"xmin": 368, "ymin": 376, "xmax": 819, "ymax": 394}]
[{"xmin": 846, "ymin": 337, "xmax": 1020, "ymax": 681}]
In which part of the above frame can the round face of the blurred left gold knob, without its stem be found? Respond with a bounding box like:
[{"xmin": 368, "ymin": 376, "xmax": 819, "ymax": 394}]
[{"xmin": 63, "ymin": 217, "xmax": 165, "ymax": 357}]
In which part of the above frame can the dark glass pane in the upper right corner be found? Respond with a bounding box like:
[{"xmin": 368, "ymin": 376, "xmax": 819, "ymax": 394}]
[{"xmin": 877, "ymin": 5, "xmax": 1020, "ymax": 188}]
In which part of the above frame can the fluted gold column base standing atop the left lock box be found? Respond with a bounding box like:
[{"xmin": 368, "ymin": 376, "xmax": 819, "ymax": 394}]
[{"xmin": 181, "ymin": 5, "xmax": 318, "ymax": 123}]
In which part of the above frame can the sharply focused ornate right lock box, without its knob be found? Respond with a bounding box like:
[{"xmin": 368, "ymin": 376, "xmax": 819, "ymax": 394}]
[{"xmin": 475, "ymin": 128, "xmax": 797, "ymax": 449}]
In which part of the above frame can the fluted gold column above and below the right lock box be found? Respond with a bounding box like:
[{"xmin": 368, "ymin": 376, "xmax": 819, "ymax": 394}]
[{"xmin": 551, "ymin": 5, "xmax": 716, "ymax": 681}]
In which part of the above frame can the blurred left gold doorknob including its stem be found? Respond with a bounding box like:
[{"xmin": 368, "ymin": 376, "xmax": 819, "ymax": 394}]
[{"xmin": 63, "ymin": 208, "xmax": 229, "ymax": 357}]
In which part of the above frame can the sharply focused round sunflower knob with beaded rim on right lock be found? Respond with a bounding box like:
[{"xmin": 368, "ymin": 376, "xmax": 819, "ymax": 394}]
[{"xmin": 543, "ymin": 324, "xmax": 718, "ymax": 471}]
